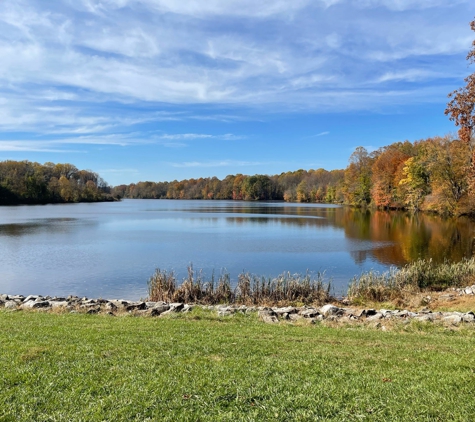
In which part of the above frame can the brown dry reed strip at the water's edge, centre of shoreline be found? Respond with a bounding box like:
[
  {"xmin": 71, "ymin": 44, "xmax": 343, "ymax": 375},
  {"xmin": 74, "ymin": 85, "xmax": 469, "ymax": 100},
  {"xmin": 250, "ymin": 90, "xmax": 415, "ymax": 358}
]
[{"xmin": 148, "ymin": 266, "xmax": 331, "ymax": 305}]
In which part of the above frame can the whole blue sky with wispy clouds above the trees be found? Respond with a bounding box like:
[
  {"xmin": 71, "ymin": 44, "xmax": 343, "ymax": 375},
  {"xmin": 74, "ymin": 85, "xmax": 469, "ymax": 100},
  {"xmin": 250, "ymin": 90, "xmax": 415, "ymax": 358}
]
[{"xmin": 0, "ymin": 0, "xmax": 475, "ymax": 185}]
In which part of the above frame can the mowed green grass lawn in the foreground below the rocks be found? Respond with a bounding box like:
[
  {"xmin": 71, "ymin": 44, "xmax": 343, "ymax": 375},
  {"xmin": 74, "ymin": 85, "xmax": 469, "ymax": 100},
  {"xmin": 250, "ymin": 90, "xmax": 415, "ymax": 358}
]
[{"xmin": 0, "ymin": 310, "xmax": 475, "ymax": 421}]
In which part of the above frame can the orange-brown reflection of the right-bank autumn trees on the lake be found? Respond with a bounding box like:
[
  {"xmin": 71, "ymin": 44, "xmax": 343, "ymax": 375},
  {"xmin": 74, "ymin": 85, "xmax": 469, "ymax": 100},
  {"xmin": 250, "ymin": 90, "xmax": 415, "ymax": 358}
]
[{"xmin": 180, "ymin": 204, "xmax": 475, "ymax": 266}]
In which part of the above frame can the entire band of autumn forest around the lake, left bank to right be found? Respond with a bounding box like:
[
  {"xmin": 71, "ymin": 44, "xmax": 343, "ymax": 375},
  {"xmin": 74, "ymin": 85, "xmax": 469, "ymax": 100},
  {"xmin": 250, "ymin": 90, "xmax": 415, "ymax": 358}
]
[{"xmin": 0, "ymin": 135, "xmax": 475, "ymax": 215}]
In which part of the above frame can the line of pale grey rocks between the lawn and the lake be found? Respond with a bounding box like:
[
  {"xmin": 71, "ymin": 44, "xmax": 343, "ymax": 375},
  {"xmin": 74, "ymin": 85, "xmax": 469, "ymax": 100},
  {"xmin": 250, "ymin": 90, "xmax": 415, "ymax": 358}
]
[{"xmin": 0, "ymin": 292, "xmax": 475, "ymax": 328}]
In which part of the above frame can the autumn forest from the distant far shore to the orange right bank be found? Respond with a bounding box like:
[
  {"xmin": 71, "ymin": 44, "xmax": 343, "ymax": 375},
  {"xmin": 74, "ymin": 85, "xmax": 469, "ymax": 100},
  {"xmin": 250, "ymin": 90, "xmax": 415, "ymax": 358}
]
[{"xmin": 111, "ymin": 135, "xmax": 475, "ymax": 215}]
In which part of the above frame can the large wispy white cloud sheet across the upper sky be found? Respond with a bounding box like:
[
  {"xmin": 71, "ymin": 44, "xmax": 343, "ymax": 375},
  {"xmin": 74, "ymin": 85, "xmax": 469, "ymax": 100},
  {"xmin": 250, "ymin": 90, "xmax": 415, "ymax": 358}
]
[{"xmin": 0, "ymin": 0, "xmax": 473, "ymax": 135}]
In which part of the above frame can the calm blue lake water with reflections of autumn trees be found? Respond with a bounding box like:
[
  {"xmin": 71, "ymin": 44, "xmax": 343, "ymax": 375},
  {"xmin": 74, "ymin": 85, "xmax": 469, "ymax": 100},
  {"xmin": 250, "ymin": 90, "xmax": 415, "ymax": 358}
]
[{"xmin": 0, "ymin": 200, "xmax": 475, "ymax": 299}]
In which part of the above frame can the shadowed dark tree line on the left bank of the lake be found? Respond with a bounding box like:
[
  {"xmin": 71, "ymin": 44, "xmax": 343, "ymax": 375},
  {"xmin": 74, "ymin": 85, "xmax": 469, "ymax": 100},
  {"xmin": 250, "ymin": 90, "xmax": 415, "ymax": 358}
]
[{"xmin": 0, "ymin": 160, "xmax": 113, "ymax": 205}]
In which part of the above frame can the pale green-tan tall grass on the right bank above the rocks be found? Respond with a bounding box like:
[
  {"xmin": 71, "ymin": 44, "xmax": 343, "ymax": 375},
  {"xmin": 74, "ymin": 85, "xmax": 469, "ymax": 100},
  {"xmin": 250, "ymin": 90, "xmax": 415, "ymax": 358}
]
[{"xmin": 348, "ymin": 258, "xmax": 475, "ymax": 302}]
